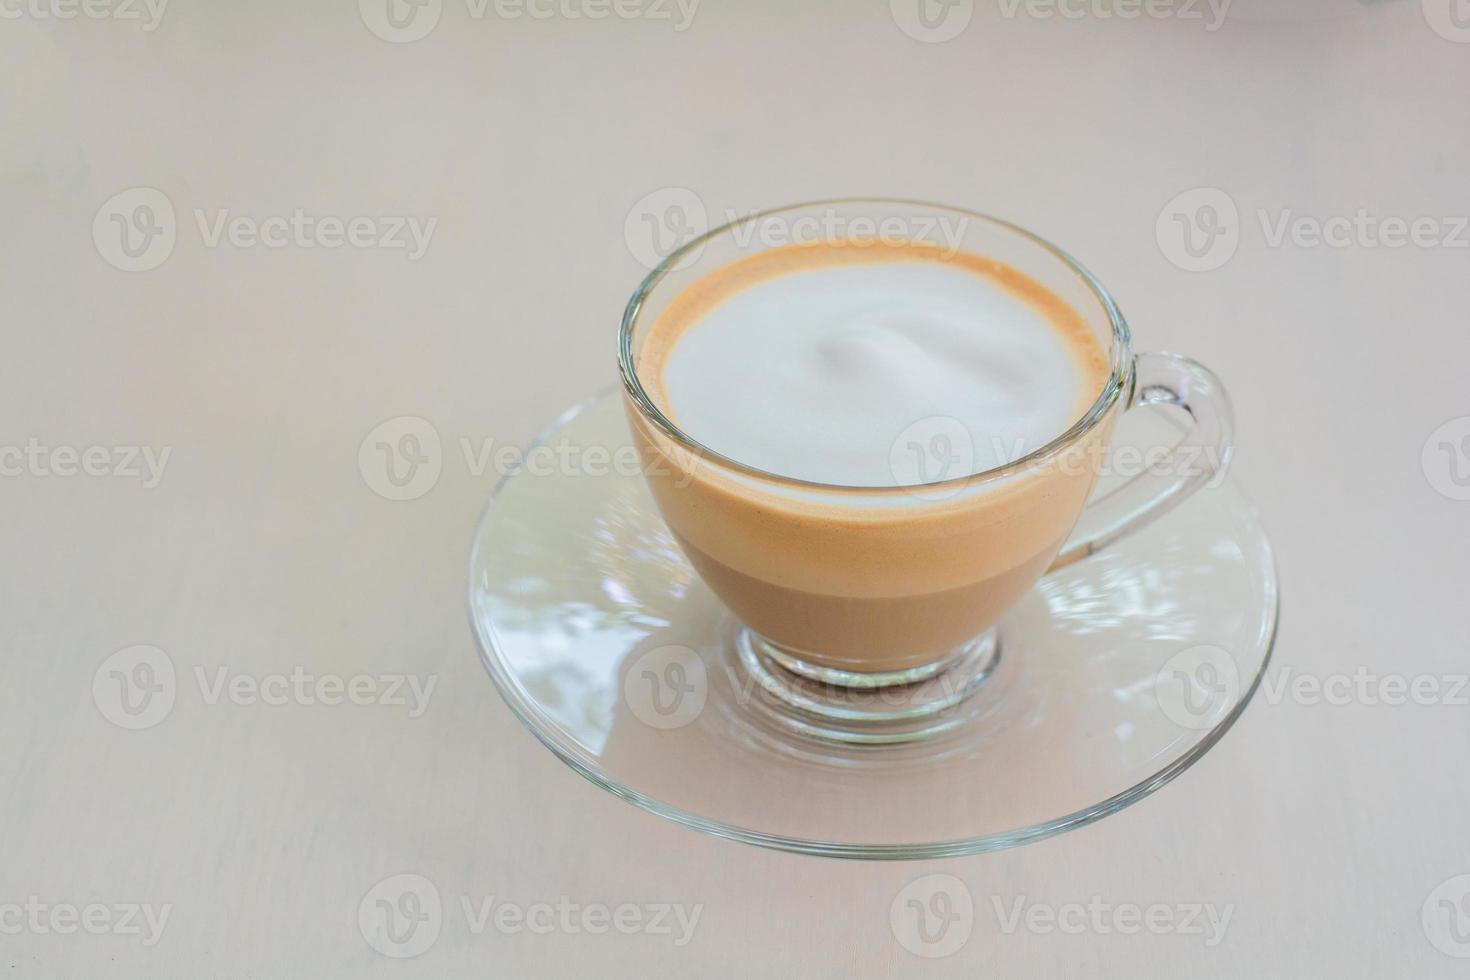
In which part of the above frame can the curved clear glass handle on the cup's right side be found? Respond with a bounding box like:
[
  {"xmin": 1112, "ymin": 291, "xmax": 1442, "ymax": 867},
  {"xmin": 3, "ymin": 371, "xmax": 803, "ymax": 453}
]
[{"xmin": 1047, "ymin": 353, "xmax": 1235, "ymax": 572}]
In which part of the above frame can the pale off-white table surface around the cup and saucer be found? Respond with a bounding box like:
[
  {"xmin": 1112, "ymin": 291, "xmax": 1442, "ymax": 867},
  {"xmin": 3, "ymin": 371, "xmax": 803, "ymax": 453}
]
[{"xmin": 0, "ymin": 0, "xmax": 1470, "ymax": 977}]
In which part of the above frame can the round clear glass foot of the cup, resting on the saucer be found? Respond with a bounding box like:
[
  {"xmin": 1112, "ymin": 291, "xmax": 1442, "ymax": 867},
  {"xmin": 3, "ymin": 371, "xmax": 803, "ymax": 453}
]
[{"xmin": 734, "ymin": 626, "xmax": 1001, "ymax": 745}]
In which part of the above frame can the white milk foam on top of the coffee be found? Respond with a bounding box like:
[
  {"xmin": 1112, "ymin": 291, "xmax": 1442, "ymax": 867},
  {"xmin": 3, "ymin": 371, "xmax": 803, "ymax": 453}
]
[{"xmin": 663, "ymin": 262, "xmax": 1085, "ymax": 486}]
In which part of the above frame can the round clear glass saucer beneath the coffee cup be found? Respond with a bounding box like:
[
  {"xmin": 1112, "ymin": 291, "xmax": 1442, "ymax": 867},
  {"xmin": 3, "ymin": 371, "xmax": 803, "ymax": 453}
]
[{"xmin": 469, "ymin": 392, "xmax": 1277, "ymax": 860}]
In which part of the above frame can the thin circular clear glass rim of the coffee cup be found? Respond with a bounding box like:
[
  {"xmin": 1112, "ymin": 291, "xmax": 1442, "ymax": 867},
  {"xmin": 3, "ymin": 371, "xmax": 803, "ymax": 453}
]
[{"xmin": 617, "ymin": 197, "xmax": 1132, "ymax": 495}]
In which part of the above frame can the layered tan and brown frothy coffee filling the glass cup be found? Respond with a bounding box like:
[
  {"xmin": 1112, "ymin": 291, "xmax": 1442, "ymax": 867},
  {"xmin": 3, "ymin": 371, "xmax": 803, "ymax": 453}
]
[{"xmin": 628, "ymin": 238, "xmax": 1120, "ymax": 670}]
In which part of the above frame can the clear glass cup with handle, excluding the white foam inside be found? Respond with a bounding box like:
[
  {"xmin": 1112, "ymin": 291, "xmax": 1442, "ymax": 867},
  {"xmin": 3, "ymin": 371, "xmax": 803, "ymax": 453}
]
[{"xmin": 619, "ymin": 200, "xmax": 1232, "ymax": 707}]
